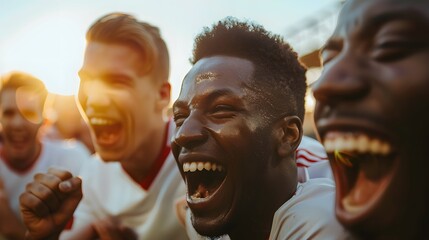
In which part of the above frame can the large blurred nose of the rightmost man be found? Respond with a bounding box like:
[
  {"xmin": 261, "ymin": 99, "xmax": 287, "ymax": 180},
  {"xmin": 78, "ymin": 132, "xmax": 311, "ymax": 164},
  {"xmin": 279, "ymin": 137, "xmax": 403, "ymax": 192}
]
[{"xmin": 312, "ymin": 50, "xmax": 369, "ymax": 104}]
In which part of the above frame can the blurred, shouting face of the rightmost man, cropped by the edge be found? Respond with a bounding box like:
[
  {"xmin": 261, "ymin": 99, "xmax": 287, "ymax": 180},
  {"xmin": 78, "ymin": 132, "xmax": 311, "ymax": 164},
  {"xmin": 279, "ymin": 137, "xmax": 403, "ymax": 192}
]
[{"xmin": 313, "ymin": 0, "xmax": 429, "ymax": 238}]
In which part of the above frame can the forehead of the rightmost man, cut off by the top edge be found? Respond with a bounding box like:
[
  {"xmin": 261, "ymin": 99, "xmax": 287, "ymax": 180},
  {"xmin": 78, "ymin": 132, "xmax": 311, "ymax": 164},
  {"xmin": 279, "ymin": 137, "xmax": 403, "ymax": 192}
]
[{"xmin": 334, "ymin": 0, "xmax": 429, "ymax": 36}]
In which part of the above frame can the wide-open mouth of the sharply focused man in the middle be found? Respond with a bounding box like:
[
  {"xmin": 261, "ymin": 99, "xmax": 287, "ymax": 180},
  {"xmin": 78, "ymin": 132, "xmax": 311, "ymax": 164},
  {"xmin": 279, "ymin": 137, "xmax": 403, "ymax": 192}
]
[{"xmin": 182, "ymin": 162, "xmax": 226, "ymax": 202}]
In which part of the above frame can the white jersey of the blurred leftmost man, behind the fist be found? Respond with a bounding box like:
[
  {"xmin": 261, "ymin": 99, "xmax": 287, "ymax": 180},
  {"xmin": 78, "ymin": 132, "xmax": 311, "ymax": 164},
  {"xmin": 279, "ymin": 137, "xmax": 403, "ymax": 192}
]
[{"xmin": 0, "ymin": 141, "xmax": 90, "ymax": 219}]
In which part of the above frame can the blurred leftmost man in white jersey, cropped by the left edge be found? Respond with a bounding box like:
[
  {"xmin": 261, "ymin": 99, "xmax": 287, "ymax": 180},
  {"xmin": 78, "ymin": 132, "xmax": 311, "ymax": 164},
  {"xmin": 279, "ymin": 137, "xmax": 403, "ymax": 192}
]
[{"xmin": 0, "ymin": 71, "xmax": 89, "ymax": 239}]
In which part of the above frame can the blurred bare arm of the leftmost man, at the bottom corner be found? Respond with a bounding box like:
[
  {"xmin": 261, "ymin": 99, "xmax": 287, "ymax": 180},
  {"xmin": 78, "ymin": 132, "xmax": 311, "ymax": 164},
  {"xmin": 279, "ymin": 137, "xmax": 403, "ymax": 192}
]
[{"xmin": 0, "ymin": 178, "xmax": 26, "ymax": 240}]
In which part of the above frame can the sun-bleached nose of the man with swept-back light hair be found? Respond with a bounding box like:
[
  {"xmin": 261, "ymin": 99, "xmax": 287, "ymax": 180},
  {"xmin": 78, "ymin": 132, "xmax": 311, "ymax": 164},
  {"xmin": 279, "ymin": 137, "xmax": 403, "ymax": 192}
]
[{"xmin": 79, "ymin": 80, "xmax": 110, "ymax": 110}]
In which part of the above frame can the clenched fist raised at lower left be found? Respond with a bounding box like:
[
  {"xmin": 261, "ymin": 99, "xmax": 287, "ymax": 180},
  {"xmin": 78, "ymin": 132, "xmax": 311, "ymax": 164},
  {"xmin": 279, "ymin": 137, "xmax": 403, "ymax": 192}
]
[{"xmin": 20, "ymin": 168, "xmax": 82, "ymax": 239}]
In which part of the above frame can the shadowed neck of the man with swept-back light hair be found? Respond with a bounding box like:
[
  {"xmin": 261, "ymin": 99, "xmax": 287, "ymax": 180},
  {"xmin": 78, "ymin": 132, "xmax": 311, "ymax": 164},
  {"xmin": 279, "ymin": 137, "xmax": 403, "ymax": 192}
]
[{"xmin": 121, "ymin": 120, "xmax": 168, "ymax": 182}]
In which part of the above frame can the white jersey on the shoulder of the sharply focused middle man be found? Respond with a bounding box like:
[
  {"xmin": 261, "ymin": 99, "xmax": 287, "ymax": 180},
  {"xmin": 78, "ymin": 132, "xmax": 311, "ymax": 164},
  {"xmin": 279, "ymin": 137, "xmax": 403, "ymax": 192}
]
[{"xmin": 270, "ymin": 178, "xmax": 351, "ymax": 240}]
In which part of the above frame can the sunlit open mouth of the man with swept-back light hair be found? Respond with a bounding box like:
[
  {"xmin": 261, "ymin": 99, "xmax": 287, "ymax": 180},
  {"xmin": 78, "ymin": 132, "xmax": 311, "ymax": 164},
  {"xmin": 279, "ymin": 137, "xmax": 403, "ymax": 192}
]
[{"xmin": 89, "ymin": 117, "xmax": 122, "ymax": 146}]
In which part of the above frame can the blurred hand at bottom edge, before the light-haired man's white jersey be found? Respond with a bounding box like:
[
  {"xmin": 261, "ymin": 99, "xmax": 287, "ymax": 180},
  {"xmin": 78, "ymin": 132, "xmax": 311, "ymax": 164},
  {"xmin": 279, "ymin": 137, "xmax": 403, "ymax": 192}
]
[{"xmin": 92, "ymin": 219, "xmax": 137, "ymax": 240}]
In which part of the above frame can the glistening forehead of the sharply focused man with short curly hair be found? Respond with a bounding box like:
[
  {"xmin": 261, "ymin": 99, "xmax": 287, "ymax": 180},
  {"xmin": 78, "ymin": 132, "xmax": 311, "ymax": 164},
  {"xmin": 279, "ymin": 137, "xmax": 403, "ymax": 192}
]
[{"xmin": 179, "ymin": 56, "xmax": 254, "ymax": 98}]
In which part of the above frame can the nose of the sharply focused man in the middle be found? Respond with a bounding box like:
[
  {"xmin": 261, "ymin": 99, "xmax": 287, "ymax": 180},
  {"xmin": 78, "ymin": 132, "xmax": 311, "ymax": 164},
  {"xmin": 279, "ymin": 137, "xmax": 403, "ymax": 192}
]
[{"xmin": 173, "ymin": 114, "xmax": 207, "ymax": 149}]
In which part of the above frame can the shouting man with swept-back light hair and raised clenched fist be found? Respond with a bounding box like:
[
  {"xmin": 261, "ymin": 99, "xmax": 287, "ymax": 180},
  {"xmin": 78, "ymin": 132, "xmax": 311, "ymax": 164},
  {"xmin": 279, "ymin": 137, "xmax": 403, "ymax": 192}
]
[{"xmin": 21, "ymin": 13, "xmax": 187, "ymax": 239}]
